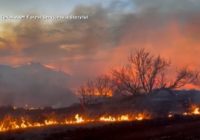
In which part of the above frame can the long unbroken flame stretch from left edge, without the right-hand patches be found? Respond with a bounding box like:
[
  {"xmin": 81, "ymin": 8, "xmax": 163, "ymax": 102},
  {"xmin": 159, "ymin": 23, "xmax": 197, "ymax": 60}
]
[{"xmin": 0, "ymin": 113, "xmax": 151, "ymax": 132}]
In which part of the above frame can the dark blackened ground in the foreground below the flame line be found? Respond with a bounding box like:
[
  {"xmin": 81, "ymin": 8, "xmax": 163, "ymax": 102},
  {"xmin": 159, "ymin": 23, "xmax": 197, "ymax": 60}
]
[{"xmin": 0, "ymin": 116, "xmax": 200, "ymax": 140}]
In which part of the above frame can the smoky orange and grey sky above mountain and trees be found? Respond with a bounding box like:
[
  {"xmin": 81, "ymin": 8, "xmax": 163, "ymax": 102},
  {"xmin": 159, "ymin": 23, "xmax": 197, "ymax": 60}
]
[{"xmin": 0, "ymin": 0, "xmax": 200, "ymax": 106}]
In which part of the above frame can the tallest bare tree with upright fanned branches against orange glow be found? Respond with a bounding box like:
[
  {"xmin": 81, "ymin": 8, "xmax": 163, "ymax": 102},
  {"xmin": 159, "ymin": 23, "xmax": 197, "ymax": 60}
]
[{"xmin": 129, "ymin": 49, "xmax": 170, "ymax": 93}]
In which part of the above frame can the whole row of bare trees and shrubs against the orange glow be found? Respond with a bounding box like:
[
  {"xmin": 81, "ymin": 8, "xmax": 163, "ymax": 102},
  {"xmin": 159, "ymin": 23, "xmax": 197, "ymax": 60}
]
[{"xmin": 78, "ymin": 49, "xmax": 199, "ymax": 104}]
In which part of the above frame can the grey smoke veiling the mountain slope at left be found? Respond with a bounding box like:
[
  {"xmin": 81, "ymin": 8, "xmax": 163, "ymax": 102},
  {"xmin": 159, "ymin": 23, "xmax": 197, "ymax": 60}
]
[{"xmin": 0, "ymin": 63, "xmax": 77, "ymax": 107}]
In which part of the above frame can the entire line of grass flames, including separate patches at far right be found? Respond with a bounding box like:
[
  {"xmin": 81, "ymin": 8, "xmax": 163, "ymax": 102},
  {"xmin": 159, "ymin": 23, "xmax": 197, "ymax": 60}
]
[{"xmin": 0, "ymin": 105, "xmax": 200, "ymax": 132}]
